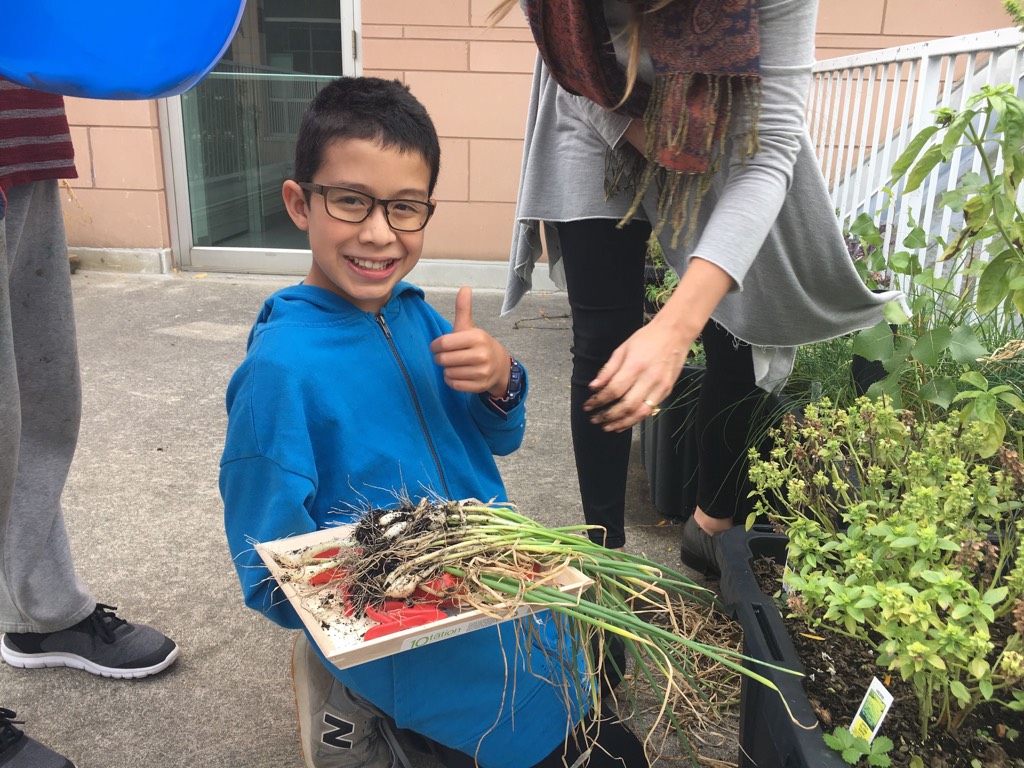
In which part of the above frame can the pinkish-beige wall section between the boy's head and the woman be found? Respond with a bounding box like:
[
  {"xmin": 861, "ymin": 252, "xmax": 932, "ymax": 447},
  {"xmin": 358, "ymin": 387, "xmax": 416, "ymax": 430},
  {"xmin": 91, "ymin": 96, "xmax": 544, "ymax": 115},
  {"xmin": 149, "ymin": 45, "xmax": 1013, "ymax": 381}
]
[{"xmin": 362, "ymin": 0, "xmax": 537, "ymax": 259}]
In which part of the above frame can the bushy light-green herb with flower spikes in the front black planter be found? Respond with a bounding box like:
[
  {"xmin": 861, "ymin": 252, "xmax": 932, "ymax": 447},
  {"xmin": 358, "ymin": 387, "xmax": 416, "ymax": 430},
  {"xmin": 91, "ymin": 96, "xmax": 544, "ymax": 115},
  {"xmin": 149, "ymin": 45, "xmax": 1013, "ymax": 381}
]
[{"xmin": 750, "ymin": 397, "xmax": 1024, "ymax": 738}]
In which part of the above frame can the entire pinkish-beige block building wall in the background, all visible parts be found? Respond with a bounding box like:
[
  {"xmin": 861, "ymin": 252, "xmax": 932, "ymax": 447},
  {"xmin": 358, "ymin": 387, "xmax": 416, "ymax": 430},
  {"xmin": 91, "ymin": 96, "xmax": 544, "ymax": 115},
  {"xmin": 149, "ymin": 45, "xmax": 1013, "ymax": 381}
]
[{"xmin": 65, "ymin": 0, "xmax": 1010, "ymax": 269}]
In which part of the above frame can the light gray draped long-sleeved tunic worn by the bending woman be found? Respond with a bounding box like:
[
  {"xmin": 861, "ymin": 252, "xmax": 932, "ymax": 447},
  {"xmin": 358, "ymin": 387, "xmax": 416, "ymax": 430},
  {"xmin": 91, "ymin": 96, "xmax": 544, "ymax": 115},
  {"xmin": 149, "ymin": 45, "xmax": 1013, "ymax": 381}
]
[{"xmin": 502, "ymin": 0, "xmax": 901, "ymax": 389}]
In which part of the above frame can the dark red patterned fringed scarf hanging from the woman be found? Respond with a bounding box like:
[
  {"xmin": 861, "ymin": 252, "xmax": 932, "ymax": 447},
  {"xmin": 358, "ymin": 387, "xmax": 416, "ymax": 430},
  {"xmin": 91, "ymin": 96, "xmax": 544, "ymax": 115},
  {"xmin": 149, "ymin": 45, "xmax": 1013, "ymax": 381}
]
[{"xmin": 526, "ymin": 0, "xmax": 761, "ymax": 248}]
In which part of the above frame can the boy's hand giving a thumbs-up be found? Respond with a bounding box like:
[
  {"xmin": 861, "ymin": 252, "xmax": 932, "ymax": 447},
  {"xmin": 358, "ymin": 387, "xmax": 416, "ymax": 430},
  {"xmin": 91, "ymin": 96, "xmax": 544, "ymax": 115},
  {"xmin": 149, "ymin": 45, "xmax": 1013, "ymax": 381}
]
[{"xmin": 430, "ymin": 286, "xmax": 509, "ymax": 397}]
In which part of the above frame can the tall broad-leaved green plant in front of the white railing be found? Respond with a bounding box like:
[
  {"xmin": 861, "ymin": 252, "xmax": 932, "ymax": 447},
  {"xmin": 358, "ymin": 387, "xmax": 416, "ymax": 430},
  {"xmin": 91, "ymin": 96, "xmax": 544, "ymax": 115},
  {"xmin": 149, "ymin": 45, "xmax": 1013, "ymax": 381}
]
[{"xmin": 850, "ymin": 85, "xmax": 1024, "ymax": 456}]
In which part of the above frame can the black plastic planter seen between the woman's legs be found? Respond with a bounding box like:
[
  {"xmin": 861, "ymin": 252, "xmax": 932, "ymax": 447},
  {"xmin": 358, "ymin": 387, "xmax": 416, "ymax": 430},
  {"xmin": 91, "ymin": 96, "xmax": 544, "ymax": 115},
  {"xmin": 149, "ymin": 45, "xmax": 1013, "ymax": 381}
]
[{"xmin": 640, "ymin": 366, "xmax": 703, "ymax": 520}]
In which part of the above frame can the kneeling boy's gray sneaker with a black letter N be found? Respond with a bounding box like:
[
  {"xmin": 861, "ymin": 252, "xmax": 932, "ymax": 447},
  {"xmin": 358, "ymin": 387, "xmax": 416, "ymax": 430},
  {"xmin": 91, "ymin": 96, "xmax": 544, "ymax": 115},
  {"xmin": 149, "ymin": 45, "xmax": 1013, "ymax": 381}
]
[{"xmin": 292, "ymin": 634, "xmax": 398, "ymax": 768}]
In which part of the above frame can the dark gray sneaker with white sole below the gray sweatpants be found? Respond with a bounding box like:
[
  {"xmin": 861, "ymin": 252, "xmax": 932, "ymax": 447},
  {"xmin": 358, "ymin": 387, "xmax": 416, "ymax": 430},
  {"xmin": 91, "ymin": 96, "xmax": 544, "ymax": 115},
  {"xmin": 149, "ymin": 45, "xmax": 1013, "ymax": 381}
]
[{"xmin": 0, "ymin": 603, "xmax": 178, "ymax": 678}]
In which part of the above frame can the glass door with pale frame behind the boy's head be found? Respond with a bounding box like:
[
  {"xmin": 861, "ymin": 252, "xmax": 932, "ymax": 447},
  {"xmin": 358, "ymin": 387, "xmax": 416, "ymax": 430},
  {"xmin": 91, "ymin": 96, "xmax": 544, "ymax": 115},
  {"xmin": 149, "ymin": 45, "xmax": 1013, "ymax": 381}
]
[{"xmin": 163, "ymin": 0, "xmax": 360, "ymax": 272}]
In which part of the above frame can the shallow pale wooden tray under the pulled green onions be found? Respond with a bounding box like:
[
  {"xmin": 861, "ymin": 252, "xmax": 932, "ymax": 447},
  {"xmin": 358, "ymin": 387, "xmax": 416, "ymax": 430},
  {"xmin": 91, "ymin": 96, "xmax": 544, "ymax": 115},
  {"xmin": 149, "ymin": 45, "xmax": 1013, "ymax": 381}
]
[{"xmin": 256, "ymin": 525, "xmax": 593, "ymax": 669}]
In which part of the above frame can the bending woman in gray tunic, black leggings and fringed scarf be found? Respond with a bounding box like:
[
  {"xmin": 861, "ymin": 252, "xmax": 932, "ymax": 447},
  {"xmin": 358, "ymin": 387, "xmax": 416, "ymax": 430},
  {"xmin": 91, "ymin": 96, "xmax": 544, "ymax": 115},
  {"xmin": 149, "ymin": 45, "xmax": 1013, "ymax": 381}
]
[{"xmin": 494, "ymin": 0, "xmax": 898, "ymax": 574}]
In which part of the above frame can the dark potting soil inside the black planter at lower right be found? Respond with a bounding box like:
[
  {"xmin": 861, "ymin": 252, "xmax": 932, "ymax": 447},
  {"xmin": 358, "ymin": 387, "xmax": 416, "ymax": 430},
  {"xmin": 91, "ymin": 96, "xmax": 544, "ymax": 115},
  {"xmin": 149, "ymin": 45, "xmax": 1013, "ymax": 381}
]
[{"xmin": 752, "ymin": 558, "xmax": 1024, "ymax": 768}]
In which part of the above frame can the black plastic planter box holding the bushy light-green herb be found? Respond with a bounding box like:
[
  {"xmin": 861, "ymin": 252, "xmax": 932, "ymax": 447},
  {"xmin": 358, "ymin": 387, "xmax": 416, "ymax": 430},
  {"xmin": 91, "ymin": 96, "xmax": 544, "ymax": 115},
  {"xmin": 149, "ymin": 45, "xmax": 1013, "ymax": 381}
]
[{"xmin": 719, "ymin": 526, "xmax": 848, "ymax": 768}]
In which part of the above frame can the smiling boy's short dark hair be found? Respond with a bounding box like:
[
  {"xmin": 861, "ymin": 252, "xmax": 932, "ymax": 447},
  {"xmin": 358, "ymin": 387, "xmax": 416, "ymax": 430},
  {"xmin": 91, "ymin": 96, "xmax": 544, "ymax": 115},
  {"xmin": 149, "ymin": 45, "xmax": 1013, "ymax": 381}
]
[{"xmin": 295, "ymin": 77, "xmax": 441, "ymax": 198}]
